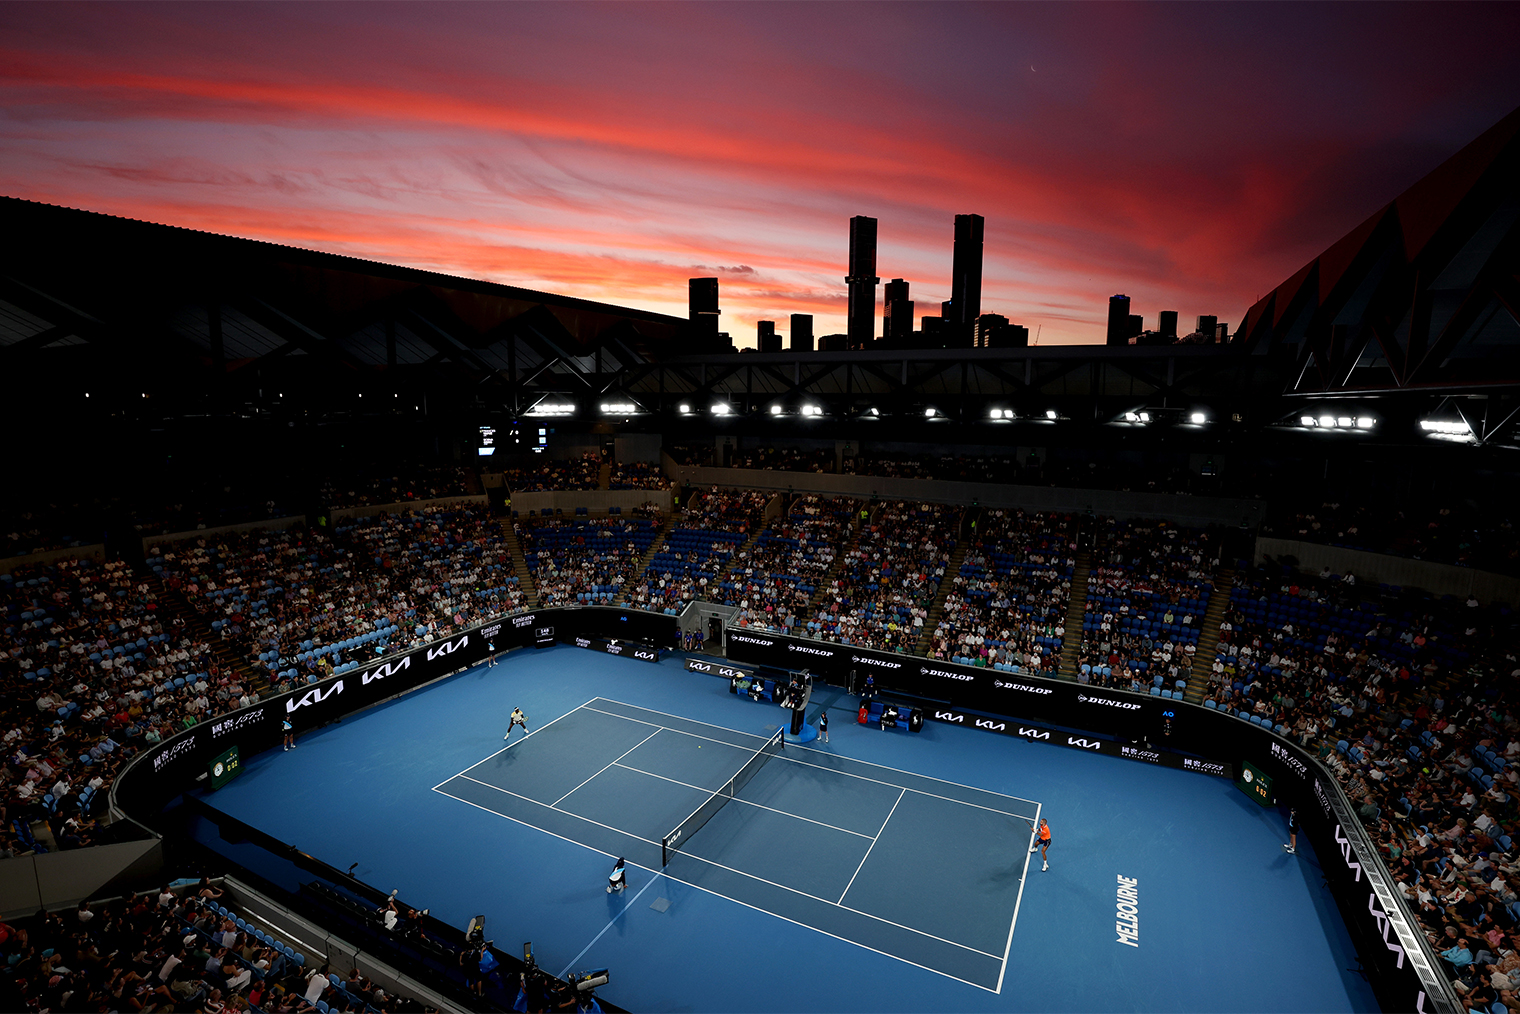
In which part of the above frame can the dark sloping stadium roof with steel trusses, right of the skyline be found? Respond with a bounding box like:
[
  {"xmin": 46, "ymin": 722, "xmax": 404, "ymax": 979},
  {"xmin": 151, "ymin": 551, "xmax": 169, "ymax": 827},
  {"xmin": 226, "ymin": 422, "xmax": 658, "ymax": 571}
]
[{"xmin": 1234, "ymin": 109, "xmax": 1520, "ymax": 395}]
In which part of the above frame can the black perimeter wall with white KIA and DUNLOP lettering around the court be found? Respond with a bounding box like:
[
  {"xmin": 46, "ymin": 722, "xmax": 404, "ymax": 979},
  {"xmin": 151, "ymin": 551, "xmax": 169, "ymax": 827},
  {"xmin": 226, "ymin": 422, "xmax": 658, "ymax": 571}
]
[{"xmin": 111, "ymin": 607, "xmax": 1461, "ymax": 1014}]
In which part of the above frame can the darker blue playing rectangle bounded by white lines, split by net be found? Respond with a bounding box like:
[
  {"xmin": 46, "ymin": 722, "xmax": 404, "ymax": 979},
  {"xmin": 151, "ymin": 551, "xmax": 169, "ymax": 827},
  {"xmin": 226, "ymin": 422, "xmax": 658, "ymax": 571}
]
[{"xmin": 435, "ymin": 698, "xmax": 1040, "ymax": 993}]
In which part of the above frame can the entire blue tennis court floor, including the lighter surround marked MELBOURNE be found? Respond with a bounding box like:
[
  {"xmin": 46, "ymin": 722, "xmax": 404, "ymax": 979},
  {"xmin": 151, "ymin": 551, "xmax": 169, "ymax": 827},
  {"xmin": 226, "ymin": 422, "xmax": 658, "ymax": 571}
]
[{"xmin": 202, "ymin": 646, "xmax": 1376, "ymax": 1014}]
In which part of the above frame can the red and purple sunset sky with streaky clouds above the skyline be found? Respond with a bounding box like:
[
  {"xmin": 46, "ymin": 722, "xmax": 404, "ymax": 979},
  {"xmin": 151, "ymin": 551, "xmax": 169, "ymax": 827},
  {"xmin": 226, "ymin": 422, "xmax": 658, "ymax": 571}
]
[{"xmin": 0, "ymin": 3, "xmax": 1520, "ymax": 345}]
